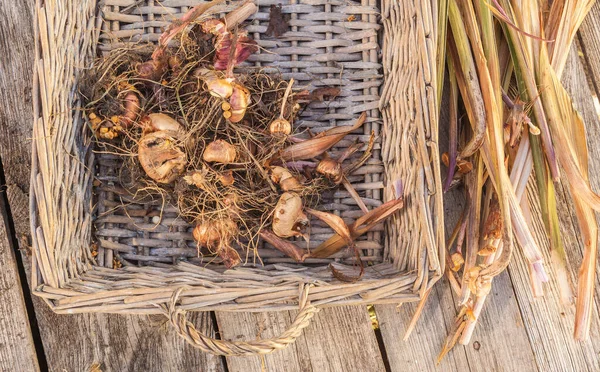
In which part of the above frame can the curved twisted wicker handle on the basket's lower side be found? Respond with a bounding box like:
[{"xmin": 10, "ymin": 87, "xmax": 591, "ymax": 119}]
[{"xmin": 162, "ymin": 285, "xmax": 319, "ymax": 356}]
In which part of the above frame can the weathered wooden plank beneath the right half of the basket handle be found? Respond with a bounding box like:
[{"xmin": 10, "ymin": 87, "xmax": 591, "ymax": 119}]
[{"xmin": 216, "ymin": 306, "xmax": 385, "ymax": 372}]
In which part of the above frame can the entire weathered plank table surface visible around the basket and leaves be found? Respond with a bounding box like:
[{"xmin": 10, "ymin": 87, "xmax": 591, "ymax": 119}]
[{"xmin": 0, "ymin": 0, "xmax": 600, "ymax": 372}]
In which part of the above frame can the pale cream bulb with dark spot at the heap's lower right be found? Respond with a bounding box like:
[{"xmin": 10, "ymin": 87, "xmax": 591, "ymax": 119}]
[{"xmin": 272, "ymin": 192, "xmax": 308, "ymax": 238}]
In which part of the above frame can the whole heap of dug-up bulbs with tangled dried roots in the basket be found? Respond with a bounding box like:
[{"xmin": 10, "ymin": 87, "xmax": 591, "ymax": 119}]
[{"xmin": 81, "ymin": 1, "xmax": 402, "ymax": 274}]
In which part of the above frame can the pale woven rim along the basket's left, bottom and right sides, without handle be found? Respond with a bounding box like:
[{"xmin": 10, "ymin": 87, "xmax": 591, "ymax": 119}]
[{"xmin": 30, "ymin": 0, "xmax": 445, "ymax": 314}]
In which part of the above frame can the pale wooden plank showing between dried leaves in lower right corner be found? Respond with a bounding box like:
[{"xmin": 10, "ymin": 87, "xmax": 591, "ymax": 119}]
[{"xmin": 500, "ymin": 47, "xmax": 600, "ymax": 371}]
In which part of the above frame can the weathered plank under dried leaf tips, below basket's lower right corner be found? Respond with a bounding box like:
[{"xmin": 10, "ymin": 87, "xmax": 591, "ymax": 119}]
[{"xmin": 375, "ymin": 192, "xmax": 538, "ymax": 371}]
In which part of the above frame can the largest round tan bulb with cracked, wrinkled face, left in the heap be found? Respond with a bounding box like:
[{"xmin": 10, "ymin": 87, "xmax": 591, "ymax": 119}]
[{"xmin": 138, "ymin": 131, "xmax": 187, "ymax": 183}]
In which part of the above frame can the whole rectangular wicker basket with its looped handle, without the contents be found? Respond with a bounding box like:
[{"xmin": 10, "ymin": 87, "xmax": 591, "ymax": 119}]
[{"xmin": 31, "ymin": 0, "xmax": 445, "ymax": 355}]
